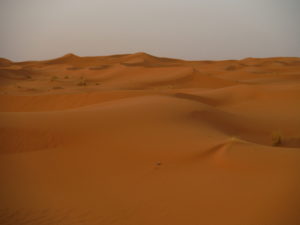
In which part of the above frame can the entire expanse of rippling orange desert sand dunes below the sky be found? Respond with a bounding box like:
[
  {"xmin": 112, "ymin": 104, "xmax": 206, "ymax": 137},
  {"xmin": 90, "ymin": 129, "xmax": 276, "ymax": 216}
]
[{"xmin": 0, "ymin": 53, "xmax": 300, "ymax": 225}]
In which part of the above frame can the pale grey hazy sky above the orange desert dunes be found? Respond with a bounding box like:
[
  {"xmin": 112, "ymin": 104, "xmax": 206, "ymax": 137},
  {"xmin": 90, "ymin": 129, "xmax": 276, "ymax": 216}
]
[{"xmin": 0, "ymin": 0, "xmax": 300, "ymax": 61}]
